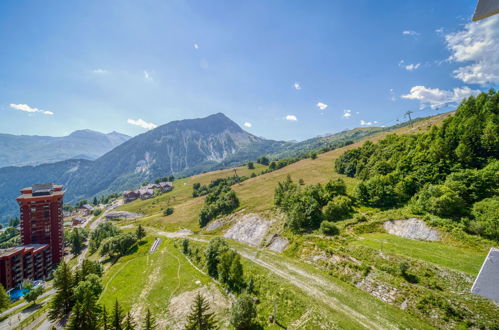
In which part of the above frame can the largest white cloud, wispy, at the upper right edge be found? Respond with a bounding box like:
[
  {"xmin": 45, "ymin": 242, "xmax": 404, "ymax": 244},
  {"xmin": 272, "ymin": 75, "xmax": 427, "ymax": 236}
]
[{"xmin": 445, "ymin": 16, "xmax": 499, "ymax": 85}]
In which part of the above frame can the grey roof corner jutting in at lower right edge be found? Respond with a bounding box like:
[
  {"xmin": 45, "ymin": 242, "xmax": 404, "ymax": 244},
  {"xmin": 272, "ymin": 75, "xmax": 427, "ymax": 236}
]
[{"xmin": 471, "ymin": 248, "xmax": 499, "ymax": 302}]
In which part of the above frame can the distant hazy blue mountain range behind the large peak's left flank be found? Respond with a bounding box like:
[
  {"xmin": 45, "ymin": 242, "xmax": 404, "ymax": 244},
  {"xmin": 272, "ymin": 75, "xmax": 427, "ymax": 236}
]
[{"xmin": 0, "ymin": 130, "xmax": 130, "ymax": 167}]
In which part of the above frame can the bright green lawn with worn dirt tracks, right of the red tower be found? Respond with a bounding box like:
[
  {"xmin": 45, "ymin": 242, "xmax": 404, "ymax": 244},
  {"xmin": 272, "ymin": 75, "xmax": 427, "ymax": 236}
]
[{"xmin": 100, "ymin": 236, "xmax": 210, "ymax": 314}]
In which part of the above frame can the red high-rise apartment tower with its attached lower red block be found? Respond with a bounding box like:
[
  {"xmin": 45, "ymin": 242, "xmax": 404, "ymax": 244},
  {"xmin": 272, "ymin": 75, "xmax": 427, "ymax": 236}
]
[{"xmin": 0, "ymin": 184, "xmax": 64, "ymax": 290}]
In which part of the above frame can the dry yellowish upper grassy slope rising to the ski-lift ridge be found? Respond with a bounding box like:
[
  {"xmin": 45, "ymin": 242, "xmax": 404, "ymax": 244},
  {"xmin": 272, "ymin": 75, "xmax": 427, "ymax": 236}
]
[{"xmin": 120, "ymin": 113, "xmax": 451, "ymax": 230}]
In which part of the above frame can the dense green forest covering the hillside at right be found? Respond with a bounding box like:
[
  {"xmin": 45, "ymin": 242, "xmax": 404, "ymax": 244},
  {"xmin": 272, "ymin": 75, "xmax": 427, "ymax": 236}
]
[{"xmin": 335, "ymin": 90, "xmax": 499, "ymax": 240}]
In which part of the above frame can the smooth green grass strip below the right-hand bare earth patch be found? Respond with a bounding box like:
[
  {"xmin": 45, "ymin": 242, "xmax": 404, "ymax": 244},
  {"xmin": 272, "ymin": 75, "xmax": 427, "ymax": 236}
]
[{"xmin": 351, "ymin": 233, "xmax": 486, "ymax": 275}]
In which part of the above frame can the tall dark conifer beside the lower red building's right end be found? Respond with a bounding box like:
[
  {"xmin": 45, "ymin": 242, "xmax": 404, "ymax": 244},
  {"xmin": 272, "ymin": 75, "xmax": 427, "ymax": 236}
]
[{"xmin": 49, "ymin": 261, "xmax": 74, "ymax": 320}]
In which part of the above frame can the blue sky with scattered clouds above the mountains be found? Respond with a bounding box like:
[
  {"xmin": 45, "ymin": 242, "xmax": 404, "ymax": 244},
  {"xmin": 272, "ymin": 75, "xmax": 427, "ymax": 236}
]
[{"xmin": 0, "ymin": 0, "xmax": 499, "ymax": 140}]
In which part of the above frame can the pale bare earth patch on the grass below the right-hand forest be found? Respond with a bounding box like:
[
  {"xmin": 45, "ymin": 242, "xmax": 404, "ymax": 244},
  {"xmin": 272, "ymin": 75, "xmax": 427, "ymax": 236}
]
[{"xmin": 383, "ymin": 218, "xmax": 440, "ymax": 241}]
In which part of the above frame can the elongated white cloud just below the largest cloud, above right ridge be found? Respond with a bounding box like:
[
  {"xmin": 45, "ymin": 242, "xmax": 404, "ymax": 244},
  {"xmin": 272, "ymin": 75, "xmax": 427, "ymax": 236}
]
[{"xmin": 401, "ymin": 86, "xmax": 480, "ymax": 109}]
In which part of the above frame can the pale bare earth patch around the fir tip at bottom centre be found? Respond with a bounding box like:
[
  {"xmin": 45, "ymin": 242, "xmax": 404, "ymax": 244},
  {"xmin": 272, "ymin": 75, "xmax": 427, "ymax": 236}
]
[{"xmin": 165, "ymin": 283, "xmax": 229, "ymax": 330}]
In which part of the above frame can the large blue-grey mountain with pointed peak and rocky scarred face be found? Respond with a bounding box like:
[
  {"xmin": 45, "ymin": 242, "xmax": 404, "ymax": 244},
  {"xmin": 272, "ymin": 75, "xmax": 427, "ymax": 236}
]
[{"xmin": 0, "ymin": 113, "xmax": 287, "ymax": 220}]
